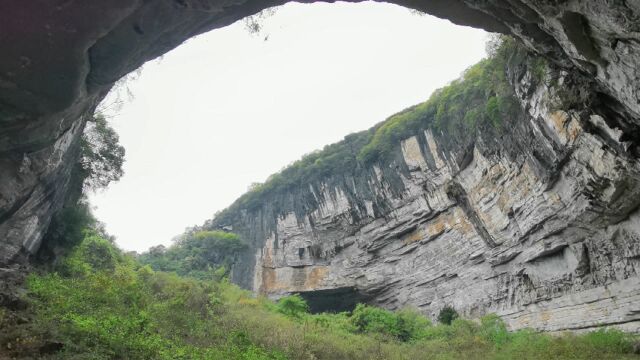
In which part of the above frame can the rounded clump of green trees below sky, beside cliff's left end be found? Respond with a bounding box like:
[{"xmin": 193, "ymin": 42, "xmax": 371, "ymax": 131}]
[{"xmin": 139, "ymin": 231, "xmax": 247, "ymax": 279}]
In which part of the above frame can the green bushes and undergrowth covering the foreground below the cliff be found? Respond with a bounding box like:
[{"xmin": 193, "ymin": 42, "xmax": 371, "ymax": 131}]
[{"xmin": 12, "ymin": 232, "xmax": 636, "ymax": 360}]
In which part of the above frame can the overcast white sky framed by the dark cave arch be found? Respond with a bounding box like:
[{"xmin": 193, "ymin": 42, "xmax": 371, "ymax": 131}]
[{"xmin": 91, "ymin": 2, "xmax": 487, "ymax": 251}]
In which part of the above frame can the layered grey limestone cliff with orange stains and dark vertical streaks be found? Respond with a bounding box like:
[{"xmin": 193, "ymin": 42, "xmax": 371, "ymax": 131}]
[{"xmin": 205, "ymin": 51, "xmax": 640, "ymax": 331}]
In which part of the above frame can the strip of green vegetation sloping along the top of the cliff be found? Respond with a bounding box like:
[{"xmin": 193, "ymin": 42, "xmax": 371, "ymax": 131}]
[{"xmin": 216, "ymin": 36, "xmax": 525, "ymax": 221}]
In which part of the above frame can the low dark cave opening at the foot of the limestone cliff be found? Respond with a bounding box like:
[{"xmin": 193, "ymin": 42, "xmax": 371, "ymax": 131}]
[{"xmin": 296, "ymin": 286, "xmax": 372, "ymax": 314}]
